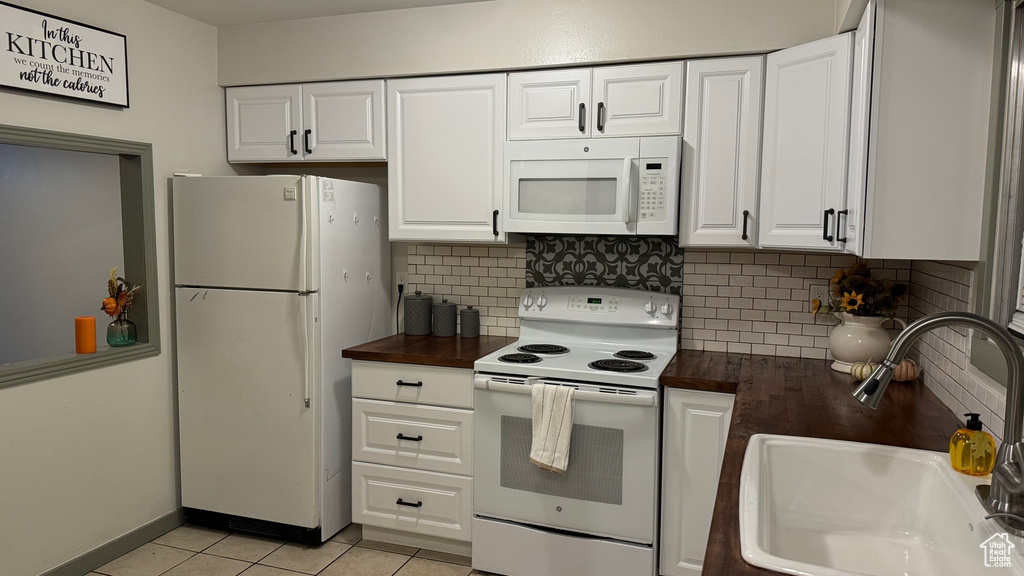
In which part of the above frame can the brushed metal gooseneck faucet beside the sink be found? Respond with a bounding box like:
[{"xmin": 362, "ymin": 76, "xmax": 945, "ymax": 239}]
[{"xmin": 853, "ymin": 312, "xmax": 1024, "ymax": 536}]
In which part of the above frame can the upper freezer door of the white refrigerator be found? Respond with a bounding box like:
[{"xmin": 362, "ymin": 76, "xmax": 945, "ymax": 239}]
[{"xmin": 171, "ymin": 176, "xmax": 319, "ymax": 291}]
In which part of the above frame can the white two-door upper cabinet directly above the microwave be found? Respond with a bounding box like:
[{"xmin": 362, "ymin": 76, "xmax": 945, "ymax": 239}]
[{"xmin": 508, "ymin": 61, "xmax": 683, "ymax": 140}]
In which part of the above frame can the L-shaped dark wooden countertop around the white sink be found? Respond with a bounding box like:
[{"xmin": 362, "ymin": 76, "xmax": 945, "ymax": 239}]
[{"xmin": 662, "ymin": 351, "xmax": 959, "ymax": 576}]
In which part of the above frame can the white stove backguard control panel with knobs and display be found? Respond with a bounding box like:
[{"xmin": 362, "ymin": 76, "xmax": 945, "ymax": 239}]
[{"xmin": 519, "ymin": 286, "xmax": 679, "ymax": 328}]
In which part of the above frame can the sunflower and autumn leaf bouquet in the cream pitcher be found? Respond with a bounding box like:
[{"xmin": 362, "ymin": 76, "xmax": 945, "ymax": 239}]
[{"xmin": 811, "ymin": 261, "xmax": 907, "ymax": 317}]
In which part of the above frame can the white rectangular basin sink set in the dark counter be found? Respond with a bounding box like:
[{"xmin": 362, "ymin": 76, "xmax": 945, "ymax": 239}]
[{"xmin": 739, "ymin": 435, "xmax": 1024, "ymax": 576}]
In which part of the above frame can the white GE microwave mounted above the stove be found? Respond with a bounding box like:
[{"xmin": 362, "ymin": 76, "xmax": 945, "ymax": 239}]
[{"xmin": 502, "ymin": 136, "xmax": 682, "ymax": 236}]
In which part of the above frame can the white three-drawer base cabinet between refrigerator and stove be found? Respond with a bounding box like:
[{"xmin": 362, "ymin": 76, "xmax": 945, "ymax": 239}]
[{"xmin": 352, "ymin": 361, "xmax": 473, "ymax": 547}]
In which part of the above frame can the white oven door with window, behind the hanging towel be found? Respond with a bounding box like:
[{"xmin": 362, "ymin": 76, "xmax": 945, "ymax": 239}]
[{"xmin": 473, "ymin": 374, "xmax": 659, "ymax": 544}]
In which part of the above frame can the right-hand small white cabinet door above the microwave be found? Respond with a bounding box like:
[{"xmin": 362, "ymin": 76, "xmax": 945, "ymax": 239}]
[{"xmin": 590, "ymin": 61, "xmax": 683, "ymax": 137}]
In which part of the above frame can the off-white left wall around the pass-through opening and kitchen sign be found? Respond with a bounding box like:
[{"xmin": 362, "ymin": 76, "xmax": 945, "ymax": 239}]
[{"xmin": 0, "ymin": 0, "xmax": 230, "ymax": 576}]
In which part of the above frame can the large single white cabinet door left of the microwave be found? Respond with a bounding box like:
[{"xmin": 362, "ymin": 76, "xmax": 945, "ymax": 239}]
[{"xmin": 387, "ymin": 74, "xmax": 506, "ymax": 242}]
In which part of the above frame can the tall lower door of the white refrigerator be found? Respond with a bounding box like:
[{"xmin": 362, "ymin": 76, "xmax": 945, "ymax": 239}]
[{"xmin": 175, "ymin": 287, "xmax": 321, "ymax": 528}]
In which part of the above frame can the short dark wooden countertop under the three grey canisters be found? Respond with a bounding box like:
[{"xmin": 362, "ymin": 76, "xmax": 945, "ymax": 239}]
[{"xmin": 341, "ymin": 334, "xmax": 515, "ymax": 369}]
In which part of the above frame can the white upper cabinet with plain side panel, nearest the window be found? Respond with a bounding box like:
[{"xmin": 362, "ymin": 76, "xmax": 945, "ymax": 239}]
[{"xmin": 849, "ymin": 0, "xmax": 995, "ymax": 260}]
